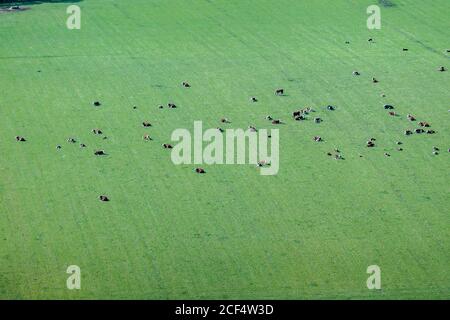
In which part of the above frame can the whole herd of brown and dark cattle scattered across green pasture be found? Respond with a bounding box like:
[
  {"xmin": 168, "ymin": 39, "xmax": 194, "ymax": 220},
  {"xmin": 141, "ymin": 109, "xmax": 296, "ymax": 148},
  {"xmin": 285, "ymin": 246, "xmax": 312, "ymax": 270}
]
[{"xmin": 15, "ymin": 44, "xmax": 450, "ymax": 202}]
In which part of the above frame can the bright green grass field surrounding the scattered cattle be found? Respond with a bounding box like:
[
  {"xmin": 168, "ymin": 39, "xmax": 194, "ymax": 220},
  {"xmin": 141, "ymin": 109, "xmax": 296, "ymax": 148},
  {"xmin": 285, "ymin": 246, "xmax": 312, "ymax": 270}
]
[{"xmin": 0, "ymin": 0, "xmax": 450, "ymax": 299}]
